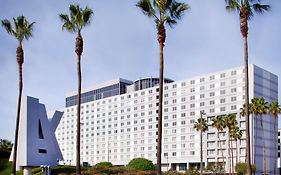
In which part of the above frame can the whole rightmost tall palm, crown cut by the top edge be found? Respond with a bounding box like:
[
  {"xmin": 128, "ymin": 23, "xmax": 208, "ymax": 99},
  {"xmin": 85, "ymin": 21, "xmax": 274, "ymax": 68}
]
[{"xmin": 225, "ymin": 0, "xmax": 270, "ymax": 175}]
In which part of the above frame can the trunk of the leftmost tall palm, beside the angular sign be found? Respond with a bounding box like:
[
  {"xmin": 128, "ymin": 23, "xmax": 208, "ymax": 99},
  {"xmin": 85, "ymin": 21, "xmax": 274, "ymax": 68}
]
[{"xmin": 12, "ymin": 42, "xmax": 24, "ymax": 175}]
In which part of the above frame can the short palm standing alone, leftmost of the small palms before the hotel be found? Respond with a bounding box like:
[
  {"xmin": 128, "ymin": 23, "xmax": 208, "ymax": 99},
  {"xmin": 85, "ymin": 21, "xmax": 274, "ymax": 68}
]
[{"xmin": 193, "ymin": 117, "xmax": 208, "ymax": 175}]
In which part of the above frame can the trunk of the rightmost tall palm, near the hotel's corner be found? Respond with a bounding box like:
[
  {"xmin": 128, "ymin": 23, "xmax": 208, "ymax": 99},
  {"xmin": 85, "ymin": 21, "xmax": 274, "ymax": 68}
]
[{"xmin": 240, "ymin": 7, "xmax": 252, "ymax": 175}]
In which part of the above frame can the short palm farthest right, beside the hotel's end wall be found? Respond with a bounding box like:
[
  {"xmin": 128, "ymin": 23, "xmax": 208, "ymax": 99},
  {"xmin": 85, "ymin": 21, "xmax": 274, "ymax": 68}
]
[{"xmin": 268, "ymin": 101, "xmax": 281, "ymax": 175}]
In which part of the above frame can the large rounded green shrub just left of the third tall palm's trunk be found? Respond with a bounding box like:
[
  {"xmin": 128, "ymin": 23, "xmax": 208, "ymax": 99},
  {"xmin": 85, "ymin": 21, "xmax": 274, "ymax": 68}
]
[{"xmin": 128, "ymin": 158, "xmax": 155, "ymax": 171}]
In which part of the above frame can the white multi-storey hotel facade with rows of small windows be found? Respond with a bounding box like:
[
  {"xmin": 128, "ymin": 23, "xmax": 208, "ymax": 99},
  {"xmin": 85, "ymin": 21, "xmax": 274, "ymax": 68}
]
[{"xmin": 56, "ymin": 65, "xmax": 278, "ymax": 172}]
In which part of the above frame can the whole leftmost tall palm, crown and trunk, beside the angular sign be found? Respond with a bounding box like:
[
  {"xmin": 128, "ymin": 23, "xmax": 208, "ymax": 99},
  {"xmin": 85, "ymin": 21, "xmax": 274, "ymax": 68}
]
[{"xmin": 1, "ymin": 16, "xmax": 34, "ymax": 175}]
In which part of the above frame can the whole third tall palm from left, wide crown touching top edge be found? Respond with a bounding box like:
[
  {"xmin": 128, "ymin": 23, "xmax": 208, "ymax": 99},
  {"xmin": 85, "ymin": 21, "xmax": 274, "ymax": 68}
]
[{"xmin": 136, "ymin": 0, "xmax": 189, "ymax": 175}]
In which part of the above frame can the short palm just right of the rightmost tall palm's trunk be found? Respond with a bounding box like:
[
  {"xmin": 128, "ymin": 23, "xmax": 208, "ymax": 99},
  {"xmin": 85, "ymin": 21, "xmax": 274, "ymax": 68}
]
[{"xmin": 252, "ymin": 98, "xmax": 268, "ymax": 175}]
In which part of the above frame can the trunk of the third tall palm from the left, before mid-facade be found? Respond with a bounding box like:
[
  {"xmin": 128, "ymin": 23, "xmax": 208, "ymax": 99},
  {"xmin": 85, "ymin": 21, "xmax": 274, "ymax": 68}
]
[{"xmin": 157, "ymin": 25, "xmax": 166, "ymax": 175}]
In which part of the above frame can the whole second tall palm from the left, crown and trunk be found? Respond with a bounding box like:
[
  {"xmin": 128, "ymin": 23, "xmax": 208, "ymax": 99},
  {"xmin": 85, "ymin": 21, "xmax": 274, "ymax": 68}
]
[{"xmin": 59, "ymin": 5, "xmax": 93, "ymax": 175}]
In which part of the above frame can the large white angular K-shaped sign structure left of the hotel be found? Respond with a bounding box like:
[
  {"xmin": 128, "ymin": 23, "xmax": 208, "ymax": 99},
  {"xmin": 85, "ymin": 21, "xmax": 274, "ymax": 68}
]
[{"xmin": 10, "ymin": 96, "xmax": 63, "ymax": 167}]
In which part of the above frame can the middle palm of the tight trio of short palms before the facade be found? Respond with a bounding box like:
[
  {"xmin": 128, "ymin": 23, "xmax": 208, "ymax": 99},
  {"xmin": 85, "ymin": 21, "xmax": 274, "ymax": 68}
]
[{"xmin": 224, "ymin": 114, "xmax": 237, "ymax": 173}]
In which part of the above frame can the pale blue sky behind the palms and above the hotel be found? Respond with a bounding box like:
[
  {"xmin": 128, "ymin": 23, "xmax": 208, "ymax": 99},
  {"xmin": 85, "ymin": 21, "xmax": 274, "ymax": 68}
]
[{"xmin": 0, "ymin": 0, "xmax": 281, "ymax": 140}]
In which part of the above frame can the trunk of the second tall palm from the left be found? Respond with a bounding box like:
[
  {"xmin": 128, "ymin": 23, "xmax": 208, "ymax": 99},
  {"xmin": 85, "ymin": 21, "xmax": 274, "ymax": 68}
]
[{"xmin": 75, "ymin": 31, "xmax": 83, "ymax": 175}]
